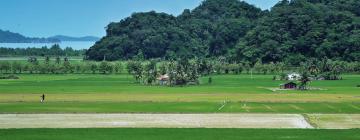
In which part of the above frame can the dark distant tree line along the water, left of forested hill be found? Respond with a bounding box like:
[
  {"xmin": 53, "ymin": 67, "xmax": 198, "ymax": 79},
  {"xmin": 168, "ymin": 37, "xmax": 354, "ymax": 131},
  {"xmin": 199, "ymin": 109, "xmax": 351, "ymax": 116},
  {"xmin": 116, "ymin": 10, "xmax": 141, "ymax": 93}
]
[{"xmin": 0, "ymin": 44, "xmax": 86, "ymax": 56}]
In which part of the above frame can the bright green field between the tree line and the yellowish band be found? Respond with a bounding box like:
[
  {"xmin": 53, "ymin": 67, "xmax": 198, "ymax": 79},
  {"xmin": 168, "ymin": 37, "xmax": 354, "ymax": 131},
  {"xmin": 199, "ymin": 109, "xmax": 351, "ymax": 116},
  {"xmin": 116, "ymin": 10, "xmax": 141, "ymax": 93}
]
[{"xmin": 0, "ymin": 74, "xmax": 360, "ymax": 94}]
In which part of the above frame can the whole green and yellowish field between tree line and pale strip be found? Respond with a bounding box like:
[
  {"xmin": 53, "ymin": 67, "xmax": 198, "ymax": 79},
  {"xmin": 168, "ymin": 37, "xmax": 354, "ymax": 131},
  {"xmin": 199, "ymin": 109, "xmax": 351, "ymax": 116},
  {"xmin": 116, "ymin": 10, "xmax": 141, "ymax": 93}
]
[{"xmin": 0, "ymin": 74, "xmax": 360, "ymax": 114}]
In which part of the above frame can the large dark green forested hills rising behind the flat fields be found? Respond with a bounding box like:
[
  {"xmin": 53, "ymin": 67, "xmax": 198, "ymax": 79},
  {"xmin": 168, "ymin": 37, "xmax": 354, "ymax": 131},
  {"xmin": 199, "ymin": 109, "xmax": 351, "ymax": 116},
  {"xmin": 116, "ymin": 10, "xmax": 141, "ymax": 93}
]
[{"xmin": 86, "ymin": 0, "xmax": 360, "ymax": 64}]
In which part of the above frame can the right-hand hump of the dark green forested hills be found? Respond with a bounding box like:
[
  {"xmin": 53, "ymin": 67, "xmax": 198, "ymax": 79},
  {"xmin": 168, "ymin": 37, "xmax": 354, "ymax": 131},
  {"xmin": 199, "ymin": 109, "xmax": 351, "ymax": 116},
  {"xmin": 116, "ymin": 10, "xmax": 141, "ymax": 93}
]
[{"xmin": 236, "ymin": 0, "xmax": 360, "ymax": 64}]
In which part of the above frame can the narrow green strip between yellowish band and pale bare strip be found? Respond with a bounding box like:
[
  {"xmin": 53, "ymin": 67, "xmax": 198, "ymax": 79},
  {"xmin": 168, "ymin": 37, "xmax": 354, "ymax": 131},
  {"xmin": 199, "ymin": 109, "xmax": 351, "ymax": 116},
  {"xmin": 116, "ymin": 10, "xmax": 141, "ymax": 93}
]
[{"xmin": 0, "ymin": 101, "xmax": 360, "ymax": 114}]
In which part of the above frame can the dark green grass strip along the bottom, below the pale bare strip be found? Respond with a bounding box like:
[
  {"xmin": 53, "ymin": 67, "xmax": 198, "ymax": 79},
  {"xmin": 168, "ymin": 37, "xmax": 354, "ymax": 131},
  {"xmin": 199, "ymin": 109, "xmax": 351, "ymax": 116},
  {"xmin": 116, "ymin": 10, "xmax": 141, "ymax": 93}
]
[{"xmin": 0, "ymin": 128, "xmax": 360, "ymax": 140}]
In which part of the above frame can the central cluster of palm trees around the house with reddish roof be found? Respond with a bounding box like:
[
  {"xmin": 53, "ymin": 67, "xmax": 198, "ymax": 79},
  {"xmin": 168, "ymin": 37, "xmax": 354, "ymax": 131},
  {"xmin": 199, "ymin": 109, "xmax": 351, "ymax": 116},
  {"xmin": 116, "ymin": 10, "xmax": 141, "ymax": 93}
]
[{"xmin": 126, "ymin": 60, "xmax": 201, "ymax": 86}]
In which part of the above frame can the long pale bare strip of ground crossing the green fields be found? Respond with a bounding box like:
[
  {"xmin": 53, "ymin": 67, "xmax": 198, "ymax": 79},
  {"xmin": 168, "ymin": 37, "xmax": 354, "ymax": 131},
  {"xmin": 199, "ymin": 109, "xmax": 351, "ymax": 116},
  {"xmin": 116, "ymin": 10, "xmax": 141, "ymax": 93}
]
[{"xmin": 0, "ymin": 114, "xmax": 312, "ymax": 128}]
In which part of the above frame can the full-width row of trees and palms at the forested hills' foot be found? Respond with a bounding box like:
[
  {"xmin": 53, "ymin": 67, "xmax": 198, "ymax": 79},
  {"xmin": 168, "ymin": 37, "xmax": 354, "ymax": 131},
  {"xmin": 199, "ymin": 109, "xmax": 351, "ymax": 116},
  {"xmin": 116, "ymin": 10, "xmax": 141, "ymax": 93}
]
[{"xmin": 0, "ymin": 57, "xmax": 360, "ymax": 85}]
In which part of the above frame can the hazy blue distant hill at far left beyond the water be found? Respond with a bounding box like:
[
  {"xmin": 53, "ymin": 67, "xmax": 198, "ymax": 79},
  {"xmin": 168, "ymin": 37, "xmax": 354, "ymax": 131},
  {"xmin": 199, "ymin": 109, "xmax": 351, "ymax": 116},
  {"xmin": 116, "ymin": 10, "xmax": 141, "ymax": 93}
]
[{"xmin": 0, "ymin": 30, "xmax": 60, "ymax": 43}]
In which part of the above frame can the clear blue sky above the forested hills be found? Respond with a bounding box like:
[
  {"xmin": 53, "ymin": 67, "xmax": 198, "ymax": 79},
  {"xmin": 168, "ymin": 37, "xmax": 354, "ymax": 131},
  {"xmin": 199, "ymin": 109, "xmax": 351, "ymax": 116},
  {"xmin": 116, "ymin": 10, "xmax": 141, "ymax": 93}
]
[{"xmin": 0, "ymin": 0, "xmax": 279, "ymax": 37}]
